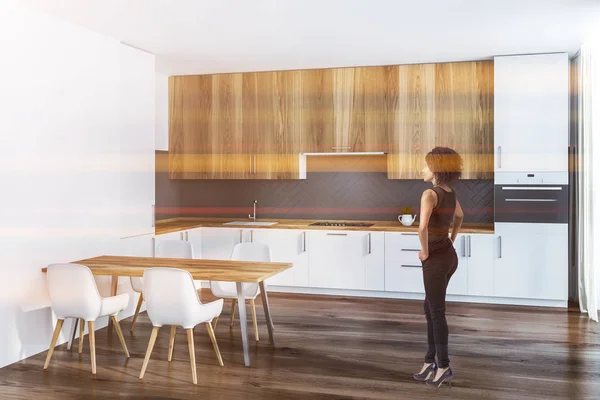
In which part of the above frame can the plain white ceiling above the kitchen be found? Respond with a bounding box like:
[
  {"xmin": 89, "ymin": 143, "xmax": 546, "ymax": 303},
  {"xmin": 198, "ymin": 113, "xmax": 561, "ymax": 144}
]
[{"xmin": 22, "ymin": 0, "xmax": 600, "ymax": 75}]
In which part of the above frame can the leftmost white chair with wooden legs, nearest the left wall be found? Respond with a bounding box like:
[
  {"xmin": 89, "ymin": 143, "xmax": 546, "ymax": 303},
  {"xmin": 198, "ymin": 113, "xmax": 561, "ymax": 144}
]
[{"xmin": 44, "ymin": 264, "xmax": 129, "ymax": 374}]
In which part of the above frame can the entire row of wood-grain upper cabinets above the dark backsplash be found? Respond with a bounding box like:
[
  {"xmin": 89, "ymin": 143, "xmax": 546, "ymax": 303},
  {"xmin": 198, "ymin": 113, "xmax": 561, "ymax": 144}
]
[{"xmin": 169, "ymin": 61, "xmax": 493, "ymax": 179}]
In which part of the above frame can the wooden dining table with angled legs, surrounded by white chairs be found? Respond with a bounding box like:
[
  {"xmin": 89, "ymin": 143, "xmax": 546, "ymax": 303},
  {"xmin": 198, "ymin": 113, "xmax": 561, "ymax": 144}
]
[{"xmin": 42, "ymin": 256, "xmax": 292, "ymax": 367}]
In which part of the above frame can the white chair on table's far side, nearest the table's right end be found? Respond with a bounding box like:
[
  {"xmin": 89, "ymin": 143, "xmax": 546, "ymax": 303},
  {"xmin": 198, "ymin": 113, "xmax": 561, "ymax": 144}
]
[{"xmin": 210, "ymin": 242, "xmax": 271, "ymax": 342}]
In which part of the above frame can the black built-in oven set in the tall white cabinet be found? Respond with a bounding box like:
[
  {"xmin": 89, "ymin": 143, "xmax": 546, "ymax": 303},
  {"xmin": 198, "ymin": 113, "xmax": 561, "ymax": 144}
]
[{"xmin": 494, "ymin": 184, "xmax": 569, "ymax": 224}]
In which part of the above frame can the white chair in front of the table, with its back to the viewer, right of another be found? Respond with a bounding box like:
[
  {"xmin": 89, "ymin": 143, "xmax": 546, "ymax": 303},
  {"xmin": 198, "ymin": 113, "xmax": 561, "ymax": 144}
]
[{"xmin": 140, "ymin": 268, "xmax": 223, "ymax": 384}]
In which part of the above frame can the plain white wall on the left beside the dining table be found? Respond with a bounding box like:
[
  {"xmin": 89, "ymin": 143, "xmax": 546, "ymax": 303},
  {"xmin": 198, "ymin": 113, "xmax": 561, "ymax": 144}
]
[{"xmin": 0, "ymin": 0, "xmax": 142, "ymax": 367}]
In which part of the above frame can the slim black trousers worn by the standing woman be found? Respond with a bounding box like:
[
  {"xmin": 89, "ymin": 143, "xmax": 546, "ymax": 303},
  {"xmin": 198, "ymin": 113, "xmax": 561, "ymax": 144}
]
[{"xmin": 423, "ymin": 243, "xmax": 458, "ymax": 368}]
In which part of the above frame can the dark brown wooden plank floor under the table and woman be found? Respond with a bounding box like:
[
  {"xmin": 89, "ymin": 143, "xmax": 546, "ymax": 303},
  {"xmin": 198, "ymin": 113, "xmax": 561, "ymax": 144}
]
[{"xmin": 0, "ymin": 294, "xmax": 600, "ymax": 400}]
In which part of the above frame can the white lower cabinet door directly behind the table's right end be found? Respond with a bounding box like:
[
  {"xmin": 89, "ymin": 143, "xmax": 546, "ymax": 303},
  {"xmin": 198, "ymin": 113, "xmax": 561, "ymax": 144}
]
[{"xmin": 250, "ymin": 229, "xmax": 308, "ymax": 287}]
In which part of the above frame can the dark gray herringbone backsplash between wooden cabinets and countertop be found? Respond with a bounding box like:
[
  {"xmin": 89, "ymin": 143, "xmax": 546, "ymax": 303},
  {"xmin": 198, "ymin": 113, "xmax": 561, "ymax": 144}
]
[{"xmin": 156, "ymin": 152, "xmax": 494, "ymax": 223}]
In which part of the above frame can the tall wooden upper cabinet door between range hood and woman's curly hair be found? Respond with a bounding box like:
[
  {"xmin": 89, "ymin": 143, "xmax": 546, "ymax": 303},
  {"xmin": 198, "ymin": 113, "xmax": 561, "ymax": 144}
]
[{"xmin": 388, "ymin": 64, "xmax": 436, "ymax": 179}]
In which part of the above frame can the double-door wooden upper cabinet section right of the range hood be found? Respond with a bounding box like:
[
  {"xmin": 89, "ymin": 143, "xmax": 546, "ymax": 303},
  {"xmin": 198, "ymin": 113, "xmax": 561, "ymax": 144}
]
[{"xmin": 388, "ymin": 61, "xmax": 494, "ymax": 179}]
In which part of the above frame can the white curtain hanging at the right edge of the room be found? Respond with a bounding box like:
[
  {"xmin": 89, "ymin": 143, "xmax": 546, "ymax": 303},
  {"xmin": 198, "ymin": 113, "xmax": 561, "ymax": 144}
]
[{"xmin": 577, "ymin": 42, "xmax": 600, "ymax": 322}]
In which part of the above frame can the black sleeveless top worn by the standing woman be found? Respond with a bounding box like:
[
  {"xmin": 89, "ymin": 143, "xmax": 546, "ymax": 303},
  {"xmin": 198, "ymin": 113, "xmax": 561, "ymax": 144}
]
[{"xmin": 427, "ymin": 187, "xmax": 456, "ymax": 253}]
